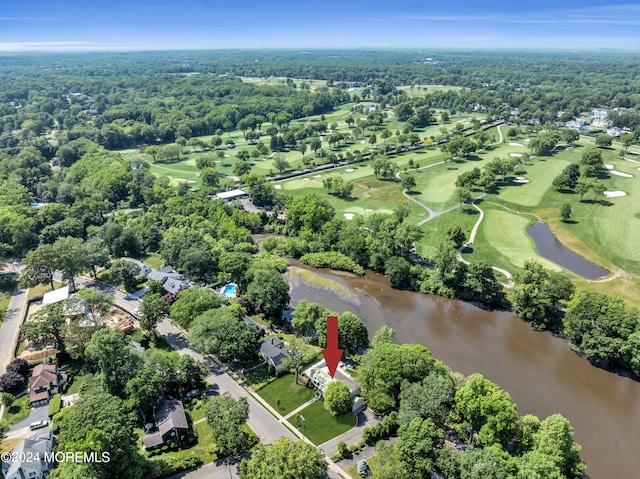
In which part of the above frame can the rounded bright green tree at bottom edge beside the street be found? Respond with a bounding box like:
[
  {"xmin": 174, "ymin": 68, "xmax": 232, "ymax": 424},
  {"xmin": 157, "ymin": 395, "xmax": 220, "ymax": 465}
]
[{"xmin": 240, "ymin": 437, "xmax": 328, "ymax": 479}]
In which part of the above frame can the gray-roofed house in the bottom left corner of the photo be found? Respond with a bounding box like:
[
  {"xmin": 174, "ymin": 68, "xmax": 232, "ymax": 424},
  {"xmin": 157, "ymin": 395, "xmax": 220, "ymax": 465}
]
[{"xmin": 2, "ymin": 431, "xmax": 53, "ymax": 479}]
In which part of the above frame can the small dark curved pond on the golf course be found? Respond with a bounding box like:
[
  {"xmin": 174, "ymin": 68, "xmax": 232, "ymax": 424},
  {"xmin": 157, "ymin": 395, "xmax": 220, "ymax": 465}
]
[{"xmin": 527, "ymin": 221, "xmax": 609, "ymax": 279}]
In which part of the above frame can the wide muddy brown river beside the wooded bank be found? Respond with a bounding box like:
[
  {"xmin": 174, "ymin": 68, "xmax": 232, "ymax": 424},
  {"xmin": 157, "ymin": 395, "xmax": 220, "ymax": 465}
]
[{"xmin": 287, "ymin": 261, "xmax": 640, "ymax": 479}]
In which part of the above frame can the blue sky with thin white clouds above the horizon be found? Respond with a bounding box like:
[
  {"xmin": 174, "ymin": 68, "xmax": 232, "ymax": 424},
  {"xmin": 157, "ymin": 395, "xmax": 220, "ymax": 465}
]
[{"xmin": 0, "ymin": 0, "xmax": 640, "ymax": 51}]
